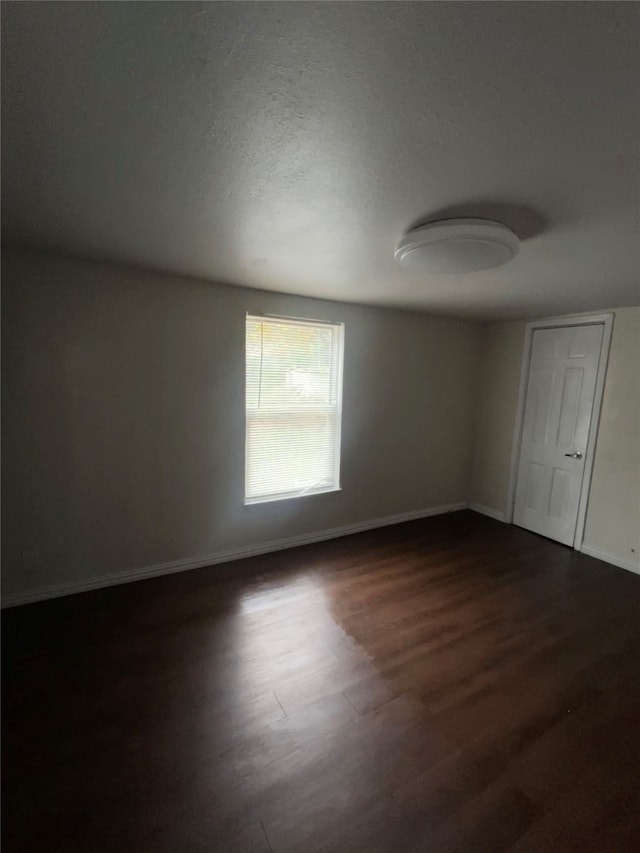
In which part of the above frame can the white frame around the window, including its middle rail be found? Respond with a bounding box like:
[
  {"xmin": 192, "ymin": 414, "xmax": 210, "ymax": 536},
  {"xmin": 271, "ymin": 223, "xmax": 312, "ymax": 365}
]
[{"xmin": 244, "ymin": 311, "xmax": 344, "ymax": 506}]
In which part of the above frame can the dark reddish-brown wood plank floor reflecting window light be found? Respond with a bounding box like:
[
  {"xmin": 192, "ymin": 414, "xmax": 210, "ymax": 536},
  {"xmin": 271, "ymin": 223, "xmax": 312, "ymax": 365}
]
[{"xmin": 3, "ymin": 512, "xmax": 640, "ymax": 853}]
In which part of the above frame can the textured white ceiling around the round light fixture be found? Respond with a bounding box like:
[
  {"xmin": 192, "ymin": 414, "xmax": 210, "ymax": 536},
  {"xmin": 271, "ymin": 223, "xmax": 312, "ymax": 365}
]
[{"xmin": 2, "ymin": 2, "xmax": 640, "ymax": 319}]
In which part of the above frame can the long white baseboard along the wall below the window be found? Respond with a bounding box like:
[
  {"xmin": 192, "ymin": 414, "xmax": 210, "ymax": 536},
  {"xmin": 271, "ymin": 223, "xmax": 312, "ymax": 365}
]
[{"xmin": 2, "ymin": 502, "xmax": 467, "ymax": 607}]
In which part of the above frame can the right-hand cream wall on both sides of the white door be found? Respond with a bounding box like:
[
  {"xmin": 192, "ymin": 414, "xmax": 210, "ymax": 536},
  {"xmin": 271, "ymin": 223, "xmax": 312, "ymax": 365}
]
[{"xmin": 469, "ymin": 307, "xmax": 640, "ymax": 571}]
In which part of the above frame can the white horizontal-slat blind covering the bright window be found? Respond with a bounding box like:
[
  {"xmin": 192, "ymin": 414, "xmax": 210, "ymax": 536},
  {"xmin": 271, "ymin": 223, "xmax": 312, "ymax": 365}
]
[{"xmin": 245, "ymin": 315, "xmax": 343, "ymax": 504}]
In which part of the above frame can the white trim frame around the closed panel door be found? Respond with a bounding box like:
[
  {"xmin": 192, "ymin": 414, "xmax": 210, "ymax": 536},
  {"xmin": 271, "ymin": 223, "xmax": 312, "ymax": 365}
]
[{"xmin": 505, "ymin": 314, "xmax": 614, "ymax": 551}]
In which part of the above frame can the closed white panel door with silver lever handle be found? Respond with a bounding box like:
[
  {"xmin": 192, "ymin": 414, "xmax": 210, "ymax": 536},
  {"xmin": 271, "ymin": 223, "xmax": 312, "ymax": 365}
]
[{"xmin": 513, "ymin": 324, "xmax": 604, "ymax": 545}]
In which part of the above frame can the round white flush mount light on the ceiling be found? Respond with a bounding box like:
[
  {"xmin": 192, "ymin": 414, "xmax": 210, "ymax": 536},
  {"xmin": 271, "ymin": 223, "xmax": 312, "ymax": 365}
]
[{"xmin": 395, "ymin": 219, "xmax": 520, "ymax": 275}]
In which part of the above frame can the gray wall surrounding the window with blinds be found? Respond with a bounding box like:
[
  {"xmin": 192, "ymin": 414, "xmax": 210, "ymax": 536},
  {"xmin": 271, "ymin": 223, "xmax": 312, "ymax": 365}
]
[{"xmin": 2, "ymin": 252, "xmax": 480, "ymax": 595}]
